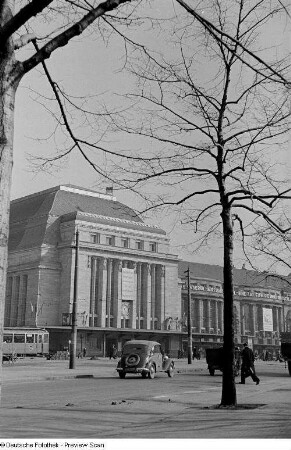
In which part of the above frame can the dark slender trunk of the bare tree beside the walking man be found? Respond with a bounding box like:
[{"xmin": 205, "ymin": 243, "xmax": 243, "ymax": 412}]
[{"xmin": 221, "ymin": 206, "xmax": 237, "ymax": 406}]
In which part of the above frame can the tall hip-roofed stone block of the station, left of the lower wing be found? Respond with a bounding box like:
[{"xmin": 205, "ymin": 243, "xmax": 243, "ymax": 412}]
[{"xmin": 5, "ymin": 186, "xmax": 181, "ymax": 354}]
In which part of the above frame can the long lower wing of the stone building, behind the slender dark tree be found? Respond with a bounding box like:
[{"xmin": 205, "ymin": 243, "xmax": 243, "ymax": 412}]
[{"xmin": 179, "ymin": 261, "xmax": 291, "ymax": 353}]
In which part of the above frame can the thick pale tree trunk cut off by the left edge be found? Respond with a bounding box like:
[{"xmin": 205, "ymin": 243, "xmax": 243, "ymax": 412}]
[{"xmin": 0, "ymin": 1, "xmax": 18, "ymax": 398}]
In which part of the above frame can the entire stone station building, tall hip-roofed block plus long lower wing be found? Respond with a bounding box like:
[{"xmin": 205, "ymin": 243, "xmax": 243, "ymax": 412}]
[{"xmin": 5, "ymin": 186, "xmax": 291, "ymax": 356}]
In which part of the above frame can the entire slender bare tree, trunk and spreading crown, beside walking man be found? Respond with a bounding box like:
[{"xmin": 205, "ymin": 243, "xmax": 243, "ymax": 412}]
[{"xmin": 100, "ymin": 0, "xmax": 291, "ymax": 407}]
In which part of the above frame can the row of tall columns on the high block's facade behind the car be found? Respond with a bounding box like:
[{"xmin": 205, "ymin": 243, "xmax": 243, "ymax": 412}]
[{"xmin": 89, "ymin": 257, "xmax": 165, "ymax": 329}]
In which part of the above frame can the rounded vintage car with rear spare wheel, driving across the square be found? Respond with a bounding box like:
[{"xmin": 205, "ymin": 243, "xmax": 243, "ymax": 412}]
[{"xmin": 116, "ymin": 340, "xmax": 175, "ymax": 379}]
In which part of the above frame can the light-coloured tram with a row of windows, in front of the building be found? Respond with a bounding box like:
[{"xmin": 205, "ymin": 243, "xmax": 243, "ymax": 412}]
[{"xmin": 3, "ymin": 327, "xmax": 49, "ymax": 357}]
